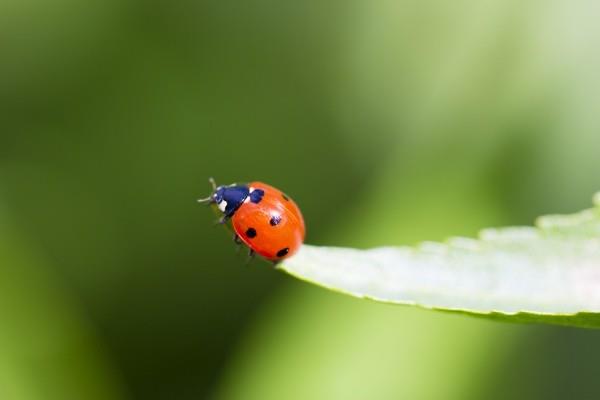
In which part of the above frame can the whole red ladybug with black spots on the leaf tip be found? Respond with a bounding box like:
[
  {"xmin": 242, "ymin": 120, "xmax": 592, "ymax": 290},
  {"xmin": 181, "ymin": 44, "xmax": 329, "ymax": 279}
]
[{"xmin": 198, "ymin": 178, "xmax": 305, "ymax": 263}]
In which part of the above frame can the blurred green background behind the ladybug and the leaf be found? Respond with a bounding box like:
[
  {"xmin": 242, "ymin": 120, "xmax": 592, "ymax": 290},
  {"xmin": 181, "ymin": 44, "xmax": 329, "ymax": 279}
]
[{"xmin": 0, "ymin": 0, "xmax": 600, "ymax": 400}]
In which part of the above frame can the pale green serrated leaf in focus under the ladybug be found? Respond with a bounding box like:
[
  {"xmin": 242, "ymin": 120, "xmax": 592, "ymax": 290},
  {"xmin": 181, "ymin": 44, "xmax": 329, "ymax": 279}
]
[{"xmin": 279, "ymin": 193, "xmax": 600, "ymax": 328}]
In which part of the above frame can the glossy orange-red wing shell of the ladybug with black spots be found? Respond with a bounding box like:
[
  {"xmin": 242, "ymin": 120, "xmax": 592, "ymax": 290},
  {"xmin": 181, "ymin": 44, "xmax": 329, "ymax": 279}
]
[{"xmin": 231, "ymin": 182, "xmax": 305, "ymax": 261}]
